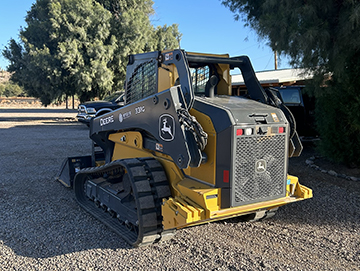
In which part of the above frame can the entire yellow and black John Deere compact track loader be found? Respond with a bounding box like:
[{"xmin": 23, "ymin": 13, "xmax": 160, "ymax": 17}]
[{"xmin": 58, "ymin": 50, "xmax": 312, "ymax": 246}]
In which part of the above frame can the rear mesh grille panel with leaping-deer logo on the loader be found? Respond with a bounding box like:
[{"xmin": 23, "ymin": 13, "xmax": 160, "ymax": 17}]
[{"xmin": 233, "ymin": 135, "xmax": 286, "ymax": 206}]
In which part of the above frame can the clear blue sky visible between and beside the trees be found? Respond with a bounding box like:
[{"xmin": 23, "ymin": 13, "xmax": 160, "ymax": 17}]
[{"xmin": 0, "ymin": 0, "xmax": 290, "ymax": 71}]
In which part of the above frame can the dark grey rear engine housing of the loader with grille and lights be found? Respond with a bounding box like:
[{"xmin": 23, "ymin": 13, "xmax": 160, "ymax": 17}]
[{"xmin": 194, "ymin": 96, "xmax": 289, "ymax": 208}]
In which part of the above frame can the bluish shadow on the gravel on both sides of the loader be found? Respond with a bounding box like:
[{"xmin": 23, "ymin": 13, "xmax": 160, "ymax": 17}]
[{"xmin": 0, "ymin": 115, "xmax": 360, "ymax": 258}]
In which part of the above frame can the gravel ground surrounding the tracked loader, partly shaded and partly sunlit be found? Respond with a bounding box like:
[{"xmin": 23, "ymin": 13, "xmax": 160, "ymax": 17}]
[{"xmin": 0, "ymin": 108, "xmax": 360, "ymax": 270}]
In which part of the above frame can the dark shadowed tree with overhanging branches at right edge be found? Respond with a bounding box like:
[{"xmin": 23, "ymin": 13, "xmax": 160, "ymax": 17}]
[{"xmin": 222, "ymin": 0, "xmax": 360, "ymax": 164}]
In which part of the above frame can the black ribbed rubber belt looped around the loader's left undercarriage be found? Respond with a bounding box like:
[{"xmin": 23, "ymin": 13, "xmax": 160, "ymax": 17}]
[{"xmin": 74, "ymin": 158, "xmax": 174, "ymax": 247}]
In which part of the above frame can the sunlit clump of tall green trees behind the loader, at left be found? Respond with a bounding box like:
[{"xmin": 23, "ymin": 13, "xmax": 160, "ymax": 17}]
[{"xmin": 3, "ymin": 0, "xmax": 181, "ymax": 105}]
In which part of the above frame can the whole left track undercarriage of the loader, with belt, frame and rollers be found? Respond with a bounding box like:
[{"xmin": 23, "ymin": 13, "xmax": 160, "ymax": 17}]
[{"xmin": 74, "ymin": 158, "xmax": 174, "ymax": 247}]
